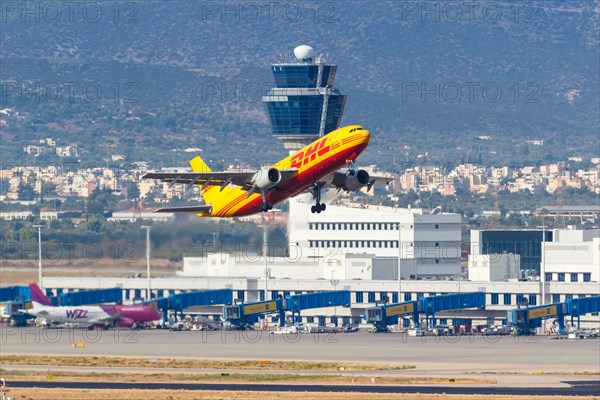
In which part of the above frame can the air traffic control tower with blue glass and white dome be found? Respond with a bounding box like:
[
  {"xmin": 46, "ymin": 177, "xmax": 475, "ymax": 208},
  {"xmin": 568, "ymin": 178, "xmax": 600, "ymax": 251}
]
[{"xmin": 263, "ymin": 45, "xmax": 346, "ymax": 150}]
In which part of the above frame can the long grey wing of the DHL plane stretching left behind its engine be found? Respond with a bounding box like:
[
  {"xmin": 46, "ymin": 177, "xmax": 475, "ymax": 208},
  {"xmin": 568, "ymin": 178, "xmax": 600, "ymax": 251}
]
[{"xmin": 142, "ymin": 168, "xmax": 298, "ymax": 192}]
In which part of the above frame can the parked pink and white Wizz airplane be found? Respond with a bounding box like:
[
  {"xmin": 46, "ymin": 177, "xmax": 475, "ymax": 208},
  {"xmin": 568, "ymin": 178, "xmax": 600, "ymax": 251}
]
[{"xmin": 27, "ymin": 283, "xmax": 162, "ymax": 328}]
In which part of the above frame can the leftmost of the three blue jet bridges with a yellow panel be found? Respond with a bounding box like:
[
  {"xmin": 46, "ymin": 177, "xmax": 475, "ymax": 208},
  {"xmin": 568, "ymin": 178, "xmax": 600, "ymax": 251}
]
[{"xmin": 223, "ymin": 290, "xmax": 350, "ymax": 326}]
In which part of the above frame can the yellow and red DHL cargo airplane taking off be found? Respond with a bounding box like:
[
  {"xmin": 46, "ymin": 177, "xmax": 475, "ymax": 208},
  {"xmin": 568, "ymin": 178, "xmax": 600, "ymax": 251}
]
[{"xmin": 142, "ymin": 125, "xmax": 392, "ymax": 217}]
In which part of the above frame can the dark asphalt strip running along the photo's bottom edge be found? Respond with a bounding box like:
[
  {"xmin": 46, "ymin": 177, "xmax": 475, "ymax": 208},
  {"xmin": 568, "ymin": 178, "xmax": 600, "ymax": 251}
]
[{"xmin": 10, "ymin": 381, "xmax": 600, "ymax": 396}]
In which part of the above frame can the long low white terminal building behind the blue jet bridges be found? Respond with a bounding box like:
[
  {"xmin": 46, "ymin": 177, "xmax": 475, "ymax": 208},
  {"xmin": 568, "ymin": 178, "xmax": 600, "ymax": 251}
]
[{"xmin": 44, "ymin": 227, "xmax": 600, "ymax": 325}]
